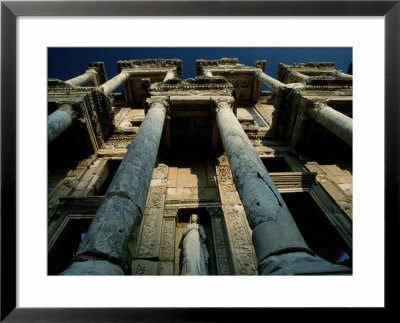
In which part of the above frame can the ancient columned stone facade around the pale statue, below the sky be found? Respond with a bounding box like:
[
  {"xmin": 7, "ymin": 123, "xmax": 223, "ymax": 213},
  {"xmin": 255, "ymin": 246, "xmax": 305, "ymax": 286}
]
[{"xmin": 48, "ymin": 58, "xmax": 352, "ymax": 275}]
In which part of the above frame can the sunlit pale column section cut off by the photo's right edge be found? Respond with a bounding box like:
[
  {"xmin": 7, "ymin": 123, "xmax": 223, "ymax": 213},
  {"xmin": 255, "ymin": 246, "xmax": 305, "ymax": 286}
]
[{"xmin": 311, "ymin": 106, "xmax": 353, "ymax": 146}]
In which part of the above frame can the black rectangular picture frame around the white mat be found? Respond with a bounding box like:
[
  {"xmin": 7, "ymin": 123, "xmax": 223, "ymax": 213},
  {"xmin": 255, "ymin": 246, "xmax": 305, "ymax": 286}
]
[{"xmin": 1, "ymin": 0, "xmax": 400, "ymax": 322}]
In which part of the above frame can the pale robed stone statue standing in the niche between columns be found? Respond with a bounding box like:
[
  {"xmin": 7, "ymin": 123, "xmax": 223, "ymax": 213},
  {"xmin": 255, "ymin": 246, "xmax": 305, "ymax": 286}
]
[{"xmin": 179, "ymin": 214, "xmax": 208, "ymax": 275}]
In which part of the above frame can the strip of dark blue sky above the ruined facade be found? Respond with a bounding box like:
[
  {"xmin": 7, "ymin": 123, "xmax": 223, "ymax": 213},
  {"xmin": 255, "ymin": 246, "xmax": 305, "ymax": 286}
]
[{"xmin": 48, "ymin": 47, "xmax": 352, "ymax": 86}]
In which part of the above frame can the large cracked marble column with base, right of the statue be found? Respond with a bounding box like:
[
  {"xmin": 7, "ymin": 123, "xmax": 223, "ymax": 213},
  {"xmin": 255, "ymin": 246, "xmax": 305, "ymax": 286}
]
[{"xmin": 216, "ymin": 99, "xmax": 349, "ymax": 275}]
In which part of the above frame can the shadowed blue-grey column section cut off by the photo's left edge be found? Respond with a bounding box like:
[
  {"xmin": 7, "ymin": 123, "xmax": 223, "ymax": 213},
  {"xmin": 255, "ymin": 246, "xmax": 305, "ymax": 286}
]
[{"xmin": 47, "ymin": 104, "xmax": 77, "ymax": 142}]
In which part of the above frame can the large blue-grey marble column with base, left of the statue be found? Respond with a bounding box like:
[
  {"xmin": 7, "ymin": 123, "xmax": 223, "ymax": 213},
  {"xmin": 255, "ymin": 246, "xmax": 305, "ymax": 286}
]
[{"xmin": 61, "ymin": 101, "xmax": 167, "ymax": 275}]
